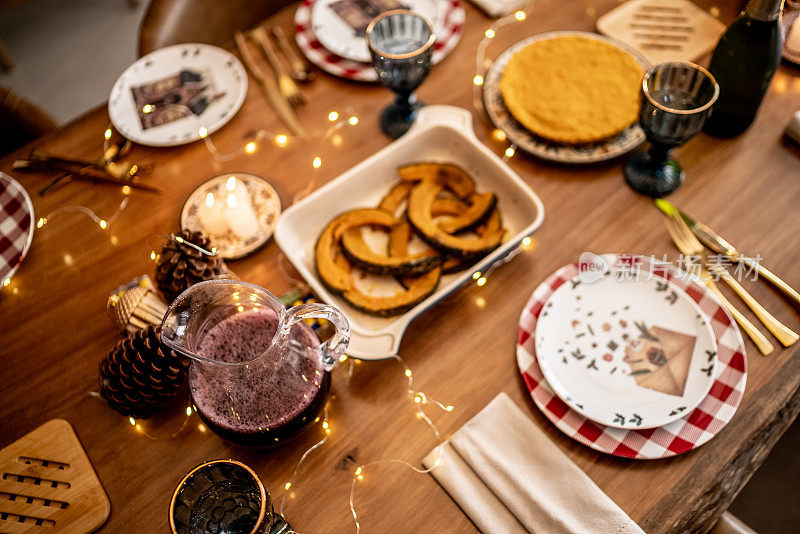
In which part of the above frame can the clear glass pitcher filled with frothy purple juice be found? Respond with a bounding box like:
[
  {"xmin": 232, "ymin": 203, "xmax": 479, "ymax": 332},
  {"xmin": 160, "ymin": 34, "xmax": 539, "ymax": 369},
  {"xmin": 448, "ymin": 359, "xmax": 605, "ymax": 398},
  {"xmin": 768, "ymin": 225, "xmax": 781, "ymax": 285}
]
[{"xmin": 161, "ymin": 280, "xmax": 350, "ymax": 446}]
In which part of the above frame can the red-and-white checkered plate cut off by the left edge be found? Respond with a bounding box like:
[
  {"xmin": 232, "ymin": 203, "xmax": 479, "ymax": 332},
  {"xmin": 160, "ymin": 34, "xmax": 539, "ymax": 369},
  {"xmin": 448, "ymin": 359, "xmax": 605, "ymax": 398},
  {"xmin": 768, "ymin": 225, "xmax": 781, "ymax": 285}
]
[{"xmin": 0, "ymin": 172, "xmax": 33, "ymax": 283}]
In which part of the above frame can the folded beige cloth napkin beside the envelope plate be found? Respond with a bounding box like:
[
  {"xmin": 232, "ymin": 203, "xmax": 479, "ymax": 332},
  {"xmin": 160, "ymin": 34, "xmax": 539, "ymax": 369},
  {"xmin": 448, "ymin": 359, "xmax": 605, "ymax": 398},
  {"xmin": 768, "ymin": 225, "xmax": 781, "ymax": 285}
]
[{"xmin": 422, "ymin": 393, "xmax": 643, "ymax": 534}]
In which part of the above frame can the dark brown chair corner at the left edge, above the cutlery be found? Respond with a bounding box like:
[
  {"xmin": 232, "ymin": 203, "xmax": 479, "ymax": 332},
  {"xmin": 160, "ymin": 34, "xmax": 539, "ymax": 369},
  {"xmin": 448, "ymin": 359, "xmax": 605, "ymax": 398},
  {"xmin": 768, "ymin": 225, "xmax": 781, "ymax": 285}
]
[{"xmin": 0, "ymin": 86, "xmax": 58, "ymax": 155}]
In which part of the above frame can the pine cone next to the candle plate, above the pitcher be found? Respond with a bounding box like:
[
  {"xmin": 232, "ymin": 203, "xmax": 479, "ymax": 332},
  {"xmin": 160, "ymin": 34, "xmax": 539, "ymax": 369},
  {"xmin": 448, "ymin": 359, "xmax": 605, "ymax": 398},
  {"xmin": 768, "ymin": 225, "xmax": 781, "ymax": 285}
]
[{"xmin": 156, "ymin": 230, "xmax": 224, "ymax": 302}]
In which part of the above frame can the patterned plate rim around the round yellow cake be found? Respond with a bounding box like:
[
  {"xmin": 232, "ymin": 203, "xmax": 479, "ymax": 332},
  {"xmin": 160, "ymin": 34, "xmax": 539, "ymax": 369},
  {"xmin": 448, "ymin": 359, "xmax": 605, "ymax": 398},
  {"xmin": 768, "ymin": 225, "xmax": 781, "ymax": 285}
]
[{"xmin": 483, "ymin": 31, "xmax": 650, "ymax": 163}]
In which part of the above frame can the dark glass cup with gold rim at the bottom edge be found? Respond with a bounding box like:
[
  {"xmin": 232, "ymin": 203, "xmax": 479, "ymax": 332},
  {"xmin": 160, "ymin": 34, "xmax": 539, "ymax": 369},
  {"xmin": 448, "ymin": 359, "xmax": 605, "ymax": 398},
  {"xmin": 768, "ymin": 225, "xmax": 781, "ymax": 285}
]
[{"xmin": 169, "ymin": 460, "xmax": 275, "ymax": 534}]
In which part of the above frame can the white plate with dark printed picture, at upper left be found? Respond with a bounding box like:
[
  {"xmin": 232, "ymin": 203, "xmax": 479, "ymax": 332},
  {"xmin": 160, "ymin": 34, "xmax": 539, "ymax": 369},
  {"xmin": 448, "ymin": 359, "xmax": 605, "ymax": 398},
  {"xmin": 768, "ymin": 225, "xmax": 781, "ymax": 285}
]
[{"xmin": 108, "ymin": 43, "xmax": 247, "ymax": 146}]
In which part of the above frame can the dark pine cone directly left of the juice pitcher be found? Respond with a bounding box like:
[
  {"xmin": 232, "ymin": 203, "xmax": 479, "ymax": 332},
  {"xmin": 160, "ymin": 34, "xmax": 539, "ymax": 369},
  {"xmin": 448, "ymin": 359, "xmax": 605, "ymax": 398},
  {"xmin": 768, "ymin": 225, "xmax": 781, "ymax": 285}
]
[{"xmin": 99, "ymin": 326, "xmax": 189, "ymax": 419}]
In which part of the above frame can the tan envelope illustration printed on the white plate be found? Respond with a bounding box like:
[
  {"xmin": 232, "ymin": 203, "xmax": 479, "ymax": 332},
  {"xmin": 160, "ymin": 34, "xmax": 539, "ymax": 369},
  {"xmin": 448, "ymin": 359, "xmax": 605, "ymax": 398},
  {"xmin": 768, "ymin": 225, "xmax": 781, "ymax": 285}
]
[{"xmin": 623, "ymin": 322, "xmax": 697, "ymax": 397}]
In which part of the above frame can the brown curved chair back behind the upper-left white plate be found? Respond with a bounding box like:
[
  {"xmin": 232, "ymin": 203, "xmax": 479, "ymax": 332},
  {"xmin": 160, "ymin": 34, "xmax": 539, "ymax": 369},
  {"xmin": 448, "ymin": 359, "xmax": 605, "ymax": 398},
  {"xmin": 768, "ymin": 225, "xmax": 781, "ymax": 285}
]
[{"xmin": 139, "ymin": 0, "xmax": 294, "ymax": 57}]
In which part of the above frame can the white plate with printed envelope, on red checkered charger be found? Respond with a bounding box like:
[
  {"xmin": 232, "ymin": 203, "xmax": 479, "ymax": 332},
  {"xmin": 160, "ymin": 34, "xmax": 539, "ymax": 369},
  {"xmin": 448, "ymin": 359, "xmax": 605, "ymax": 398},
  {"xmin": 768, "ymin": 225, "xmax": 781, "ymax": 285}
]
[{"xmin": 535, "ymin": 269, "xmax": 719, "ymax": 429}]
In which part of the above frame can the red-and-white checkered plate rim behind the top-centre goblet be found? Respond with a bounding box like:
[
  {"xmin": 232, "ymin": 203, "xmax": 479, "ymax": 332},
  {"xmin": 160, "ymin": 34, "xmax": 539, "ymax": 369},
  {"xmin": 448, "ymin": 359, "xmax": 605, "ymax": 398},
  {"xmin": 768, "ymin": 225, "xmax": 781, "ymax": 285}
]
[{"xmin": 294, "ymin": 0, "xmax": 466, "ymax": 82}]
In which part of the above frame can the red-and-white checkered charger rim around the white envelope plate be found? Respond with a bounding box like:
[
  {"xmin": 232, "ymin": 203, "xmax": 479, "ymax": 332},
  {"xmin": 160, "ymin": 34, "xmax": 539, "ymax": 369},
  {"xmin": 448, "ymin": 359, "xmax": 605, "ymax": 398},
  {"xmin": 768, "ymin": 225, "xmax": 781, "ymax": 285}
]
[{"xmin": 517, "ymin": 255, "xmax": 747, "ymax": 459}]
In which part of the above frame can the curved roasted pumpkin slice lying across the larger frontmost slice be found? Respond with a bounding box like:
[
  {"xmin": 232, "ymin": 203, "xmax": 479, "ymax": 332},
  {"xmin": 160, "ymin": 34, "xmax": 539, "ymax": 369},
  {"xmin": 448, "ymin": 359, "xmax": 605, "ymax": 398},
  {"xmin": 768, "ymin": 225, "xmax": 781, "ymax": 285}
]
[{"xmin": 342, "ymin": 223, "xmax": 442, "ymax": 275}]
